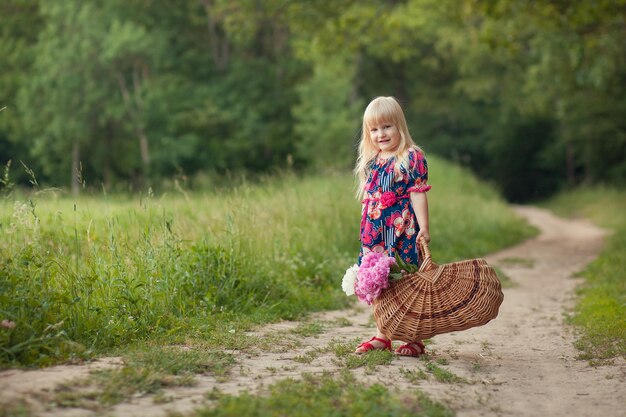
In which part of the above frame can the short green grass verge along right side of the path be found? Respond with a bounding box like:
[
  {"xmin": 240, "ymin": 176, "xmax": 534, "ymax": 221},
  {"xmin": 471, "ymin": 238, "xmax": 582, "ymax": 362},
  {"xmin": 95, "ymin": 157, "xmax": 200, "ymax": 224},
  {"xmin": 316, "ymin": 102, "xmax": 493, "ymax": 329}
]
[{"xmin": 546, "ymin": 188, "xmax": 626, "ymax": 361}]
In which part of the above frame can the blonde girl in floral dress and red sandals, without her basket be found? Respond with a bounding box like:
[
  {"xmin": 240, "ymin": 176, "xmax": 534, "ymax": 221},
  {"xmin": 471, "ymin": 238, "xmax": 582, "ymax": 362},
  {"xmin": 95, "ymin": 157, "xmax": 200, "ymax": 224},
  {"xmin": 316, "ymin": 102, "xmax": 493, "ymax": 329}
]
[{"xmin": 354, "ymin": 97, "xmax": 430, "ymax": 356}]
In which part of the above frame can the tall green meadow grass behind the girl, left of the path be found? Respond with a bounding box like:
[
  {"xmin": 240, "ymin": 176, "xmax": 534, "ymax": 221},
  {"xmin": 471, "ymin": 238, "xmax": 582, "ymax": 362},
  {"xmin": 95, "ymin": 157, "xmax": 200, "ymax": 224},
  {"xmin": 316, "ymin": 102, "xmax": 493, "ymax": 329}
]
[{"xmin": 0, "ymin": 158, "xmax": 532, "ymax": 365}]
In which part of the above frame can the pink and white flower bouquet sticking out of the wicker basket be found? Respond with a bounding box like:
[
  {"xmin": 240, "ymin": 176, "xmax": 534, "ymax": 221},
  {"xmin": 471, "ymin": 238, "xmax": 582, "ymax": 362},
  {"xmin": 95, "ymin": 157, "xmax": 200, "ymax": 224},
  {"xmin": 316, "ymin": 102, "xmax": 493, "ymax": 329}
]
[{"xmin": 341, "ymin": 252, "xmax": 418, "ymax": 304}]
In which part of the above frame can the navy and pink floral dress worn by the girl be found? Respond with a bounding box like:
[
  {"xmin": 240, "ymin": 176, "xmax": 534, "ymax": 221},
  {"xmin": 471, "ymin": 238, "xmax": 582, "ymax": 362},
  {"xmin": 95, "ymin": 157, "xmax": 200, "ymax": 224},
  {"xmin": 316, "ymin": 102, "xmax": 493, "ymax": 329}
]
[{"xmin": 358, "ymin": 149, "xmax": 431, "ymax": 265}]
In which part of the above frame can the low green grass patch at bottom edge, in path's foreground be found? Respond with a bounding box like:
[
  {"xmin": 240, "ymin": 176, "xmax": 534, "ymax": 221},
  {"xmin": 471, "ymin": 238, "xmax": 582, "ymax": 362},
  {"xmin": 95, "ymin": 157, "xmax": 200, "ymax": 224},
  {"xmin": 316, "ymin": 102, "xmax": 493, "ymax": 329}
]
[{"xmin": 193, "ymin": 373, "xmax": 454, "ymax": 417}]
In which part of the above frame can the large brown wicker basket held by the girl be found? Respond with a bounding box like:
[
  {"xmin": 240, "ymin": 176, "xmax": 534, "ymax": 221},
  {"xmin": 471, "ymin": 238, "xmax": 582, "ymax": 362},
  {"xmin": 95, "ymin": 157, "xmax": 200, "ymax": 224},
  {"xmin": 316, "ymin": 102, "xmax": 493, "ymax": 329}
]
[{"xmin": 373, "ymin": 239, "xmax": 504, "ymax": 342}]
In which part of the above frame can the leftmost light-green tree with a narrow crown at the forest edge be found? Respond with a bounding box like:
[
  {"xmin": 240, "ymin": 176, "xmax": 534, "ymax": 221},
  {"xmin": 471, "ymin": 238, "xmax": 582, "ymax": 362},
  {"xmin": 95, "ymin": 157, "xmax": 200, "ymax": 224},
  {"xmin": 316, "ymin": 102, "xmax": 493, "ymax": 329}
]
[{"xmin": 19, "ymin": 1, "xmax": 106, "ymax": 194}]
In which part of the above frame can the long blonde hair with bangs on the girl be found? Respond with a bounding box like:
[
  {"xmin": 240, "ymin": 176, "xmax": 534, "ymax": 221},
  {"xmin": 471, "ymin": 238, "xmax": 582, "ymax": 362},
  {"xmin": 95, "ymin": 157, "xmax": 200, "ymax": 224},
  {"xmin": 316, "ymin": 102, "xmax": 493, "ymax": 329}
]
[{"xmin": 354, "ymin": 97, "xmax": 421, "ymax": 199}]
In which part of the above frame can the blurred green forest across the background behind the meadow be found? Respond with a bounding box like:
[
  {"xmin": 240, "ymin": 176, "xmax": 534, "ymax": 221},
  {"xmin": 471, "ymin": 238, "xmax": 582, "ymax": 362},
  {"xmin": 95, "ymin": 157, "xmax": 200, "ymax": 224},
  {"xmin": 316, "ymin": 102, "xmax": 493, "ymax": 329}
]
[{"xmin": 0, "ymin": 0, "xmax": 626, "ymax": 201}]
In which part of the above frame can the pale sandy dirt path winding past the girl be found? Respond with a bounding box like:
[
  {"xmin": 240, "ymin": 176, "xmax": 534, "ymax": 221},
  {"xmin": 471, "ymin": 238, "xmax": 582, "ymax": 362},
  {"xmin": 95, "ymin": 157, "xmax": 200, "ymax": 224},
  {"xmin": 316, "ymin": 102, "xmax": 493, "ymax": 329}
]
[{"xmin": 0, "ymin": 207, "xmax": 626, "ymax": 417}]
